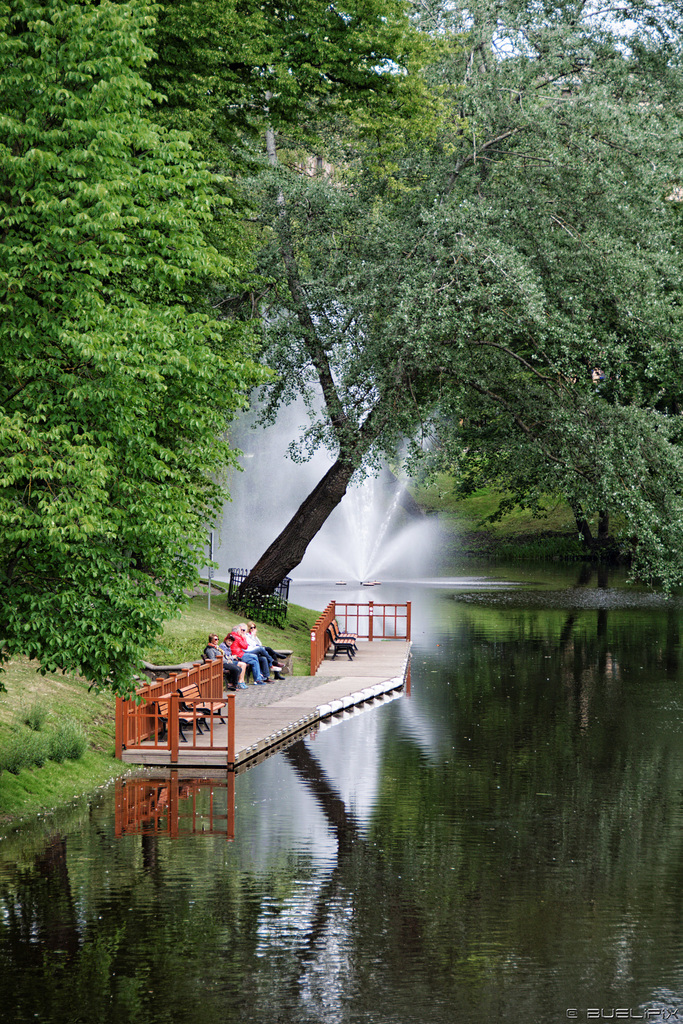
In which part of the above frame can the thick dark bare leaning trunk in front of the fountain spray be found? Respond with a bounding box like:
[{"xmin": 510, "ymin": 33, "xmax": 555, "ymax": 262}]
[{"xmin": 243, "ymin": 458, "xmax": 355, "ymax": 594}]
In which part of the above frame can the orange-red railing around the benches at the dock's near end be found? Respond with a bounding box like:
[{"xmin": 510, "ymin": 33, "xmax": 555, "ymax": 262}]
[{"xmin": 116, "ymin": 658, "xmax": 234, "ymax": 765}]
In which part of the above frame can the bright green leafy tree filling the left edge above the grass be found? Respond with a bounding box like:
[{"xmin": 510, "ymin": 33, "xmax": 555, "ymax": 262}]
[{"xmin": 0, "ymin": 0, "xmax": 263, "ymax": 692}]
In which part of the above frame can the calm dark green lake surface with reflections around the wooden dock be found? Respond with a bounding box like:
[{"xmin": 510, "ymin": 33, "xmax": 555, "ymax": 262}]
[{"xmin": 0, "ymin": 567, "xmax": 683, "ymax": 1024}]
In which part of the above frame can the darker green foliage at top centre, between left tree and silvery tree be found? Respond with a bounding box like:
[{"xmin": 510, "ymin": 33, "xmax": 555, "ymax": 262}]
[{"xmin": 146, "ymin": 0, "xmax": 426, "ymax": 168}]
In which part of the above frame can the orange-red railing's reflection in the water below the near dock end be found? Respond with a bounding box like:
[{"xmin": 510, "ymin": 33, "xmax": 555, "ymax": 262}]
[{"xmin": 116, "ymin": 771, "xmax": 234, "ymax": 840}]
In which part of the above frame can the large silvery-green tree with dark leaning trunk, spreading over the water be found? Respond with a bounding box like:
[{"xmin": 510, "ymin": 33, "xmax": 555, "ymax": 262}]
[{"xmin": 241, "ymin": 2, "xmax": 683, "ymax": 590}]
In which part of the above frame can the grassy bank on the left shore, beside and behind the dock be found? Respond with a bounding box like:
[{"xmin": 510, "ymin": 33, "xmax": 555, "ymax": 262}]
[{"xmin": 0, "ymin": 595, "xmax": 318, "ymax": 824}]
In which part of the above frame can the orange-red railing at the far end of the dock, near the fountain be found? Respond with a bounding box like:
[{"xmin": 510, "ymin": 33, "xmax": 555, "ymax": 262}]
[{"xmin": 310, "ymin": 601, "xmax": 411, "ymax": 676}]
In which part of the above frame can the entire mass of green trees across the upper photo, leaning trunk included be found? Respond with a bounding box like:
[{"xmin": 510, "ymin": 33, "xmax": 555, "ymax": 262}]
[{"xmin": 0, "ymin": 0, "xmax": 683, "ymax": 689}]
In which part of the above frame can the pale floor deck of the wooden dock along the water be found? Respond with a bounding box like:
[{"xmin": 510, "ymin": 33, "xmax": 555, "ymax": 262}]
[{"xmin": 122, "ymin": 640, "xmax": 411, "ymax": 770}]
